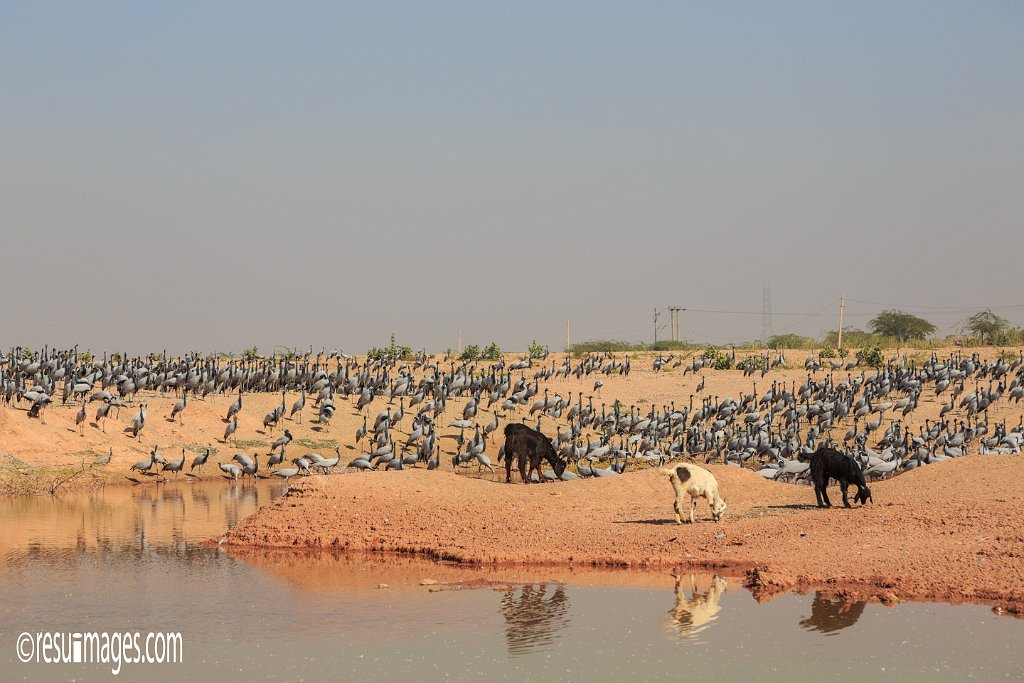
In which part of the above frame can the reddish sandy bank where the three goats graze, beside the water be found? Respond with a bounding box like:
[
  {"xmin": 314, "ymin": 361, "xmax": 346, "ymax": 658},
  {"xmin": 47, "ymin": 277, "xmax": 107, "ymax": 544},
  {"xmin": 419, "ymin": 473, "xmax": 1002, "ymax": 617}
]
[{"xmin": 221, "ymin": 456, "xmax": 1024, "ymax": 613}]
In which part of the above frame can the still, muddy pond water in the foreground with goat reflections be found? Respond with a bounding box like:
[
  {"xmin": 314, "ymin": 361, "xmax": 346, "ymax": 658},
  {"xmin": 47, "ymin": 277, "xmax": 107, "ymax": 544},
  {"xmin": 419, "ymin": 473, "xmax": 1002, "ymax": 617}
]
[{"xmin": 0, "ymin": 481, "xmax": 1024, "ymax": 683}]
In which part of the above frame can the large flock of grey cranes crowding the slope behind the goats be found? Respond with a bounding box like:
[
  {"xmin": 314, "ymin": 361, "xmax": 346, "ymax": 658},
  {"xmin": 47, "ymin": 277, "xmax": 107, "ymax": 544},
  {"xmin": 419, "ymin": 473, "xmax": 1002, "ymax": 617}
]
[{"xmin": 0, "ymin": 349, "xmax": 1024, "ymax": 489}]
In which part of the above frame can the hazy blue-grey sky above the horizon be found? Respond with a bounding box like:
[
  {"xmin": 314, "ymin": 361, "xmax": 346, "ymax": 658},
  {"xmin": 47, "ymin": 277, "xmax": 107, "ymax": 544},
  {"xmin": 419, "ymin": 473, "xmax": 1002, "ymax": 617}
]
[{"xmin": 0, "ymin": 0, "xmax": 1024, "ymax": 352}]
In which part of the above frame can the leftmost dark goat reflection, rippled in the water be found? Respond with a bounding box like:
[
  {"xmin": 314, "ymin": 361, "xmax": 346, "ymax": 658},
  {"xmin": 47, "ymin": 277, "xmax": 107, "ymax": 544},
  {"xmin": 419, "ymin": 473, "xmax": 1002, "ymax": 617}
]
[{"xmin": 501, "ymin": 584, "xmax": 569, "ymax": 655}]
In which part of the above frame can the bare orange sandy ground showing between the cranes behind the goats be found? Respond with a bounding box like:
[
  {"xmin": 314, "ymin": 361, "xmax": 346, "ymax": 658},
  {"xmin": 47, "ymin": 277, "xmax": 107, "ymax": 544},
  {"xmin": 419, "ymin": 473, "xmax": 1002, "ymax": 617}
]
[{"xmin": 0, "ymin": 347, "xmax": 1024, "ymax": 493}]
